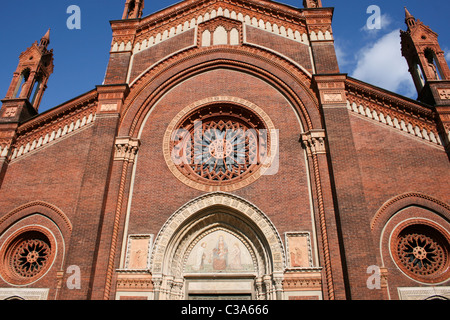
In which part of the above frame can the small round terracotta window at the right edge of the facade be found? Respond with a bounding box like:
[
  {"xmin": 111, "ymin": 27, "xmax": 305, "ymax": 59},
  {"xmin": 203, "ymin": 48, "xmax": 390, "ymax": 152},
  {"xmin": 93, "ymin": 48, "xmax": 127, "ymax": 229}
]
[{"xmin": 391, "ymin": 224, "xmax": 450, "ymax": 283}]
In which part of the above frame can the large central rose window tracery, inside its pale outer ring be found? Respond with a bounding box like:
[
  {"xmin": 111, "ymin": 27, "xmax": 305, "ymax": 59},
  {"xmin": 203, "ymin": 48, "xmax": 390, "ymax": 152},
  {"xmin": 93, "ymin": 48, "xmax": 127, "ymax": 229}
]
[{"xmin": 170, "ymin": 105, "xmax": 269, "ymax": 186}]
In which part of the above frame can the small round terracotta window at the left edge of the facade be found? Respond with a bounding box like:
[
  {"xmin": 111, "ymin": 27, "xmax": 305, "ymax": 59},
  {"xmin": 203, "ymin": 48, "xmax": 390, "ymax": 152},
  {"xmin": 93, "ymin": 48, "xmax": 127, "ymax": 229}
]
[{"xmin": 2, "ymin": 230, "xmax": 54, "ymax": 284}]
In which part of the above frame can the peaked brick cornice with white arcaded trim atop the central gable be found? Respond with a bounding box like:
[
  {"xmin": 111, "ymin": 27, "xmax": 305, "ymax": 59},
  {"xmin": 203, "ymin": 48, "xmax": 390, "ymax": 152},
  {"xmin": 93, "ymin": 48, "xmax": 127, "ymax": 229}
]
[{"xmin": 111, "ymin": 0, "xmax": 316, "ymax": 53}]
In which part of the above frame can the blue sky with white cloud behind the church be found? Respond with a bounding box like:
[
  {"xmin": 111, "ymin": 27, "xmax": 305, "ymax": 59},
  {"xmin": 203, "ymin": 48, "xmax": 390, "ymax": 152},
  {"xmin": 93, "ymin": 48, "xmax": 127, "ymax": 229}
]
[{"xmin": 0, "ymin": 0, "xmax": 450, "ymax": 112}]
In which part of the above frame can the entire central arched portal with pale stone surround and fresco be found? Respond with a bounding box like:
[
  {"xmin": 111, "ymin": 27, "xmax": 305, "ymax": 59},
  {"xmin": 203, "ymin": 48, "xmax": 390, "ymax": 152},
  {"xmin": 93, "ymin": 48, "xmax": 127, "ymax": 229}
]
[{"xmin": 151, "ymin": 193, "xmax": 285, "ymax": 300}]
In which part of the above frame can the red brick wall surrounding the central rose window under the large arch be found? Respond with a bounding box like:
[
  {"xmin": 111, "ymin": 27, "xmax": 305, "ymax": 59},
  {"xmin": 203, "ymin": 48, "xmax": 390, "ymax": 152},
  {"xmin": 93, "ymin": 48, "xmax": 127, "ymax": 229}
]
[{"xmin": 123, "ymin": 70, "xmax": 311, "ymax": 245}]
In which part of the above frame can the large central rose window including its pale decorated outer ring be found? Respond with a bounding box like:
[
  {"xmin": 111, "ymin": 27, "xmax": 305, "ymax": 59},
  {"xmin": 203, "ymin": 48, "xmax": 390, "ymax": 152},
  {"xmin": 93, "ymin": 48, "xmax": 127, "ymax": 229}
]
[{"xmin": 164, "ymin": 97, "xmax": 277, "ymax": 191}]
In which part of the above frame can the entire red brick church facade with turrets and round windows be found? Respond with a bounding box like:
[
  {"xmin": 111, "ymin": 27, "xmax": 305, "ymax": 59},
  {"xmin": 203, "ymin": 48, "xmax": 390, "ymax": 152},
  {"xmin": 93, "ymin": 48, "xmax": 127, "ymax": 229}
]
[{"xmin": 0, "ymin": 0, "xmax": 450, "ymax": 300}]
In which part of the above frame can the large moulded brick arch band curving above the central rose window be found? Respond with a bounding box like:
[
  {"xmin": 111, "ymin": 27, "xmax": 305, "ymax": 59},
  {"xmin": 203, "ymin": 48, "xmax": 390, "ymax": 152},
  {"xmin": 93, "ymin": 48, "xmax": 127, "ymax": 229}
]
[{"xmin": 119, "ymin": 46, "xmax": 322, "ymax": 137}]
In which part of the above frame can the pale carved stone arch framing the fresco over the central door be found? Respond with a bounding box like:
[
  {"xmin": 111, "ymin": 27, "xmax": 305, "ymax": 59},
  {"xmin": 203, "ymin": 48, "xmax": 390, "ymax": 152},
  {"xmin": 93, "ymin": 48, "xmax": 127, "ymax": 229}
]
[{"xmin": 150, "ymin": 192, "xmax": 285, "ymax": 299}]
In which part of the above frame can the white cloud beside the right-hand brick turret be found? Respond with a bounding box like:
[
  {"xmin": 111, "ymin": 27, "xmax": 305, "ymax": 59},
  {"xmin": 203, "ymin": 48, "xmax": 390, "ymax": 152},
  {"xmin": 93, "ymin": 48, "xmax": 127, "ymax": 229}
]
[{"xmin": 351, "ymin": 30, "xmax": 417, "ymax": 98}]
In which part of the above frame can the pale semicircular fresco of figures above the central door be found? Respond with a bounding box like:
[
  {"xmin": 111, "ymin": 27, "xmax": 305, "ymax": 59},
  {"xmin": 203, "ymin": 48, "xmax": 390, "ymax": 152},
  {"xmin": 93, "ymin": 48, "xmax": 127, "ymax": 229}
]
[{"xmin": 185, "ymin": 231, "xmax": 255, "ymax": 273}]
